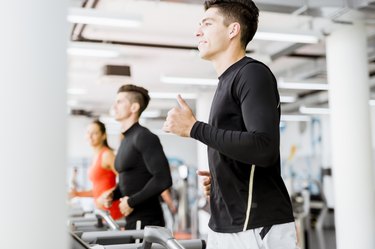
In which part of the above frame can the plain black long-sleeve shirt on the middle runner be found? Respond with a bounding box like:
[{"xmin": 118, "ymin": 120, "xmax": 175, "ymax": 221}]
[{"xmin": 114, "ymin": 123, "xmax": 172, "ymax": 222}]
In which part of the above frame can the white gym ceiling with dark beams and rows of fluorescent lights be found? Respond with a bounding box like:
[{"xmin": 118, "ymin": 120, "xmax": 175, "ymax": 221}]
[{"xmin": 67, "ymin": 0, "xmax": 375, "ymax": 121}]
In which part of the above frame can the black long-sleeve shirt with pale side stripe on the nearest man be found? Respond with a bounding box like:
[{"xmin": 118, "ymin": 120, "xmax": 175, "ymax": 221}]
[{"xmin": 190, "ymin": 57, "xmax": 294, "ymax": 233}]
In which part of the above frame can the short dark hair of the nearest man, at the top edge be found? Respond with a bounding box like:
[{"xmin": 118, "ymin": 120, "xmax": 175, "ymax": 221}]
[{"xmin": 204, "ymin": 0, "xmax": 259, "ymax": 49}]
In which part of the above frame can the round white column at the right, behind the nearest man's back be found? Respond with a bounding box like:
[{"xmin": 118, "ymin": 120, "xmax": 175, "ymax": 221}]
[{"xmin": 327, "ymin": 23, "xmax": 375, "ymax": 249}]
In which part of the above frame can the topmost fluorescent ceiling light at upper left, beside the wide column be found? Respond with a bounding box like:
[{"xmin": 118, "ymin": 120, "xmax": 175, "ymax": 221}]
[{"xmin": 67, "ymin": 8, "xmax": 141, "ymax": 28}]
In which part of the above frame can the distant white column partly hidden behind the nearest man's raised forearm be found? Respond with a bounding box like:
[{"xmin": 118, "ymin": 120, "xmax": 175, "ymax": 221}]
[{"xmin": 196, "ymin": 92, "xmax": 214, "ymax": 170}]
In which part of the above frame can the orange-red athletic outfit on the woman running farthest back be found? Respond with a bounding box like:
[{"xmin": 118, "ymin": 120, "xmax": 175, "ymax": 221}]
[{"xmin": 89, "ymin": 147, "xmax": 123, "ymax": 220}]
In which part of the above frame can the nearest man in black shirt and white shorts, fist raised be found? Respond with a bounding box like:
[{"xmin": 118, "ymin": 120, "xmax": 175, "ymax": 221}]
[{"xmin": 163, "ymin": 0, "xmax": 296, "ymax": 249}]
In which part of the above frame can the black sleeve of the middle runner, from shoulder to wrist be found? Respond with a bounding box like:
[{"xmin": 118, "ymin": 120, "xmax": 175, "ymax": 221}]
[{"xmin": 128, "ymin": 133, "xmax": 172, "ymax": 207}]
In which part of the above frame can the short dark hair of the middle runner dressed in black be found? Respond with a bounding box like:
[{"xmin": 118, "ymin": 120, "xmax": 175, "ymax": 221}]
[{"xmin": 117, "ymin": 84, "xmax": 150, "ymax": 116}]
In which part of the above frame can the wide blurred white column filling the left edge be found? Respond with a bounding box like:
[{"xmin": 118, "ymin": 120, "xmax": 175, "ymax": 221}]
[{"xmin": 0, "ymin": 0, "xmax": 68, "ymax": 249}]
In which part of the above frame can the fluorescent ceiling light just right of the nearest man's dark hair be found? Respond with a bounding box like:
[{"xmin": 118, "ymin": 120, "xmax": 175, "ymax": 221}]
[{"xmin": 254, "ymin": 30, "xmax": 320, "ymax": 43}]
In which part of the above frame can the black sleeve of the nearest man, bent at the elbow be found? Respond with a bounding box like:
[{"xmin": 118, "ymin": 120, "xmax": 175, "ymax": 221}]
[{"xmin": 190, "ymin": 63, "xmax": 280, "ymax": 167}]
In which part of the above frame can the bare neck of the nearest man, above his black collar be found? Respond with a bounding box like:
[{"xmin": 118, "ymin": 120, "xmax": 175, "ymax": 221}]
[{"xmin": 212, "ymin": 44, "xmax": 246, "ymax": 77}]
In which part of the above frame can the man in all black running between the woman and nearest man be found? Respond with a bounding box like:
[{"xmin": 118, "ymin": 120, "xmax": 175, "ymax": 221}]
[{"xmin": 109, "ymin": 85, "xmax": 172, "ymax": 230}]
